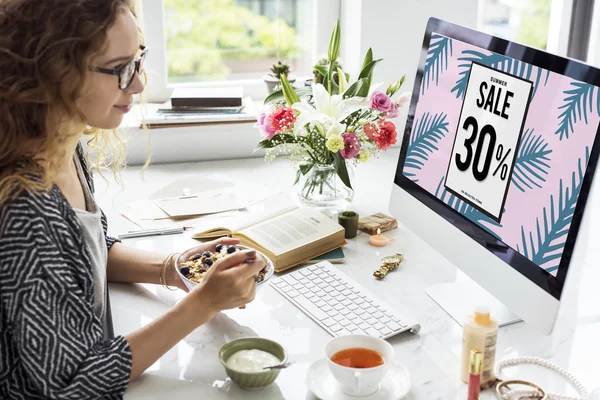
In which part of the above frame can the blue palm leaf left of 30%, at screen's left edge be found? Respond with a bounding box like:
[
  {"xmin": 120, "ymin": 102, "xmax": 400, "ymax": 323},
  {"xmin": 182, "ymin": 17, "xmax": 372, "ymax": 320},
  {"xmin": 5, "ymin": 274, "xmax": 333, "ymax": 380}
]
[{"xmin": 404, "ymin": 113, "xmax": 448, "ymax": 182}]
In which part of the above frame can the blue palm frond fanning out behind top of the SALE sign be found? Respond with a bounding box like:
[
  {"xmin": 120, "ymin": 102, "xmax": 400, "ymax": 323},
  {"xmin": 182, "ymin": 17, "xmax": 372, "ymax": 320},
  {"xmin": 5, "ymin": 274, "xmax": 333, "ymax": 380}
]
[{"xmin": 452, "ymin": 50, "xmax": 550, "ymax": 100}]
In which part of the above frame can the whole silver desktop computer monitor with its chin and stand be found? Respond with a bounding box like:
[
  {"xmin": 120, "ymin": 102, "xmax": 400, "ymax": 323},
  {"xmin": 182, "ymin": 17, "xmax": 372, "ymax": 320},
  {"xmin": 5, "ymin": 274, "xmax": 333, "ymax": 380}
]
[{"xmin": 390, "ymin": 18, "xmax": 600, "ymax": 334}]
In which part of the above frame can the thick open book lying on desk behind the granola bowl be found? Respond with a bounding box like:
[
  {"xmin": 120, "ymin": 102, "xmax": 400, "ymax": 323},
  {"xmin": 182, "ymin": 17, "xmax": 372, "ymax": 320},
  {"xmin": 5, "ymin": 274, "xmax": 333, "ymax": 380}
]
[{"xmin": 193, "ymin": 196, "xmax": 346, "ymax": 272}]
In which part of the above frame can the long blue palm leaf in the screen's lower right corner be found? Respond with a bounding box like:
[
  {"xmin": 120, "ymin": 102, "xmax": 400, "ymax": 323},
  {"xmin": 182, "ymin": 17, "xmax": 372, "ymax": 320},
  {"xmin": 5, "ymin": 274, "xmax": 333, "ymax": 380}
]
[{"xmin": 517, "ymin": 147, "xmax": 590, "ymax": 272}]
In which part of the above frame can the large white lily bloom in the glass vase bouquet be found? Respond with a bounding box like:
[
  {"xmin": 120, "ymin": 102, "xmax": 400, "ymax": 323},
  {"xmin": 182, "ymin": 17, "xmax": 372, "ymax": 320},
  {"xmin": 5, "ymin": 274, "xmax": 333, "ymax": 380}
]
[{"xmin": 292, "ymin": 83, "xmax": 367, "ymax": 138}]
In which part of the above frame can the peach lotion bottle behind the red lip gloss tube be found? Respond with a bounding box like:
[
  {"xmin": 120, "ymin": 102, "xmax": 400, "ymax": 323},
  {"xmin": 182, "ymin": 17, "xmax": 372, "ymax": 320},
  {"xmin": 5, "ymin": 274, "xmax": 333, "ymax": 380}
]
[{"xmin": 460, "ymin": 306, "xmax": 498, "ymax": 385}]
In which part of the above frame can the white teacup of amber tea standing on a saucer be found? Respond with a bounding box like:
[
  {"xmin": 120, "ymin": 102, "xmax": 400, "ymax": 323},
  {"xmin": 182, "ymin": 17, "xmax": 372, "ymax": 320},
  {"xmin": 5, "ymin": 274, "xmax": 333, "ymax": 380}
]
[{"xmin": 325, "ymin": 335, "xmax": 394, "ymax": 396}]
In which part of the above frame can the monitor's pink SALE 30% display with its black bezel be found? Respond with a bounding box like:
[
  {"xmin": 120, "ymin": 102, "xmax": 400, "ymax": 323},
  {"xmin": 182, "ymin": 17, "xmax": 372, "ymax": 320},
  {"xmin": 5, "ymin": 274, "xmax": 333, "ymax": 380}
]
[{"xmin": 395, "ymin": 20, "xmax": 600, "ymax": 299}]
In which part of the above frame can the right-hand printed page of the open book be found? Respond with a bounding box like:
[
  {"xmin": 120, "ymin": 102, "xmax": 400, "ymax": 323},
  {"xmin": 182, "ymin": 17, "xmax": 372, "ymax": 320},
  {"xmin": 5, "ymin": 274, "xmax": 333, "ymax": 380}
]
[{"xmin": 240, "ymin": 208, "xmax": 344, "ymax": 255}]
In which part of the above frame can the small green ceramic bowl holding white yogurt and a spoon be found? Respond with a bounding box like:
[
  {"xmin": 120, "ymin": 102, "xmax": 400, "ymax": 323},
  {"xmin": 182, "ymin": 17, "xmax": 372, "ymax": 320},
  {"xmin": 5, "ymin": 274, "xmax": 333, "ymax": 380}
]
[{"xmin": 219, "ymin": 337, "xmax": 287, "ymax": 389}]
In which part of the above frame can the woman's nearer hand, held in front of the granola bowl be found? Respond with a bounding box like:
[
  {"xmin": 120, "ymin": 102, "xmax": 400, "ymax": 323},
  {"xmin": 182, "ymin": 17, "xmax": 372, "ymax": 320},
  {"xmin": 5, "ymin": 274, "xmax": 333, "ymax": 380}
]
[{"xmin": 186, "ymin": 250, "xmax": 265, "ymax": 324}]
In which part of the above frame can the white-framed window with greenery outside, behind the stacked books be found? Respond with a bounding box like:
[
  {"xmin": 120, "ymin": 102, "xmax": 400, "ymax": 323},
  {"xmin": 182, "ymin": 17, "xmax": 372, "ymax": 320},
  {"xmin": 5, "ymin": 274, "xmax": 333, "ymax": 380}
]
[{"xmin": 142, "ymin": 0, "xmax": 339, "ymax": 101}]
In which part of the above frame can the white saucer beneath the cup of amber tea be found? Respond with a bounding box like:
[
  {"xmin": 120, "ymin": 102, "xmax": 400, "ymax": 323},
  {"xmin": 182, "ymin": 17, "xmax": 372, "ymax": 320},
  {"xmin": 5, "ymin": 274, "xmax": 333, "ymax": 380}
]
[{"xmin": 306, "ymin": 358, "xmax": 410, "ymax": 400}]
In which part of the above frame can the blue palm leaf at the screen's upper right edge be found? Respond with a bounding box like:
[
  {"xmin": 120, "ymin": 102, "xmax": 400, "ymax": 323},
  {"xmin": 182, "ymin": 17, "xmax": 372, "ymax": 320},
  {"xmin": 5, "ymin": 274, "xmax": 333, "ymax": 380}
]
[{"xmin": 555, "ymin": 82, "xmax": 600, "ymax": 140}]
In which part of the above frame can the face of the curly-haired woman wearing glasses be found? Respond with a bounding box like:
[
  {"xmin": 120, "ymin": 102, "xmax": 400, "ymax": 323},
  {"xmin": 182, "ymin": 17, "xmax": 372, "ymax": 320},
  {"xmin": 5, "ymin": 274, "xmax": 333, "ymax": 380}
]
[{"xmin": 77, "ymin": 11, "xmax": 144, "ymax": 129}]
